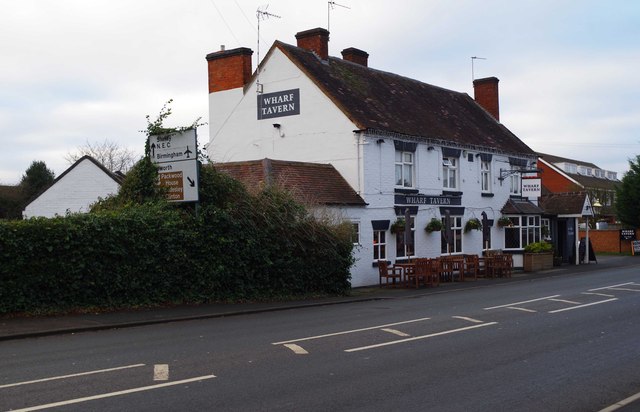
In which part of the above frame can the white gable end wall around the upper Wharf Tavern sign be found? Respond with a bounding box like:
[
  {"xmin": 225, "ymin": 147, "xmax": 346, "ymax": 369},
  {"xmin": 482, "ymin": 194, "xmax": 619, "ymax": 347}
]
[{"xmin": 207, "ymin": 48, "xmax": 359, "ymax": 191}]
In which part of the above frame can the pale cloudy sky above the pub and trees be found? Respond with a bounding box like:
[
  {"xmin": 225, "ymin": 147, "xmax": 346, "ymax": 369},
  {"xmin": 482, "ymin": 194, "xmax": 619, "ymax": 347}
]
[{"xmin": 0, "ymin": 0, "xmax": 640, "ymax": 185}]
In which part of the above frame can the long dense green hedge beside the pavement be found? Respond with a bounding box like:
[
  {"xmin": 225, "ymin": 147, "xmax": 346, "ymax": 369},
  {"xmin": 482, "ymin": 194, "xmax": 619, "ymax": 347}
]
[{"xmin": 0, "ymin": 198, "xmax": 353, "ymax": 314}]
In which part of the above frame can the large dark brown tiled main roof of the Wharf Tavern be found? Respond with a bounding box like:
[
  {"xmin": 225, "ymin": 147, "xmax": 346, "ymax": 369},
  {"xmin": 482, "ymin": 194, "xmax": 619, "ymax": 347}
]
[{"xmin": 274, "ymin": 41, "xmax": 535, "ymax": 156}]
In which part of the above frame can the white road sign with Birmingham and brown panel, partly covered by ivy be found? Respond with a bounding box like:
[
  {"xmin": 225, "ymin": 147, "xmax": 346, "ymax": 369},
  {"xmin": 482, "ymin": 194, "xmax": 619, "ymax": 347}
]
[{"xmin": 149, "ymin": 129, "xmax": 199, "ymax": 202}]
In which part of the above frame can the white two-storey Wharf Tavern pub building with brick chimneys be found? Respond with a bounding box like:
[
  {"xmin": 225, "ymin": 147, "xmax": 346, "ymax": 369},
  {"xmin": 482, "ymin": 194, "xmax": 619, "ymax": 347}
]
[{"xmin": 207, "ymin": 28, "xmax": 542, "ymax": 287}]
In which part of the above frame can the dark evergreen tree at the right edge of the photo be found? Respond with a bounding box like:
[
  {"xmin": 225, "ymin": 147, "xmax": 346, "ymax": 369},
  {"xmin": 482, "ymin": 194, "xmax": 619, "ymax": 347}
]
[{"xmin": 616, "ymin": 155, "xmax": 640, "ymax": 228}]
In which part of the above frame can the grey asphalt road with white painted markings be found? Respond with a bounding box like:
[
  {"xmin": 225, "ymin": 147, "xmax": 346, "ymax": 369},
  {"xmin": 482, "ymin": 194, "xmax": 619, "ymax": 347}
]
[{"xmin": 0, "ymin": 266, "xmax": 640, "ymax": 412}]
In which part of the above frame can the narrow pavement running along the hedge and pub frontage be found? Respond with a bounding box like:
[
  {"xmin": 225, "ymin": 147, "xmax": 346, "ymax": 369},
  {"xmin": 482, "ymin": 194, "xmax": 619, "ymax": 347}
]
[{"xmin": 0, "ymin": 256, "xmax": 640, "ymax": 341}]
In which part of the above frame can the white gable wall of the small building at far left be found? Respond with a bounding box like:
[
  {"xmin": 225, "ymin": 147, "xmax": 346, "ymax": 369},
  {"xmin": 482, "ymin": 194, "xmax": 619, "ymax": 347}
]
[{"xmin": 23, "ymin": 159, "xmax": 120, "ymax": 218}]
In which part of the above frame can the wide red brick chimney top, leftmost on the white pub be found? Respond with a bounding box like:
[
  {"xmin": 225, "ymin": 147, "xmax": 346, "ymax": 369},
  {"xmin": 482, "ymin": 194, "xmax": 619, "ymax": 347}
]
[{"xmin": 207, "ymin": 47, "xmax": 253, "ymax": 93}]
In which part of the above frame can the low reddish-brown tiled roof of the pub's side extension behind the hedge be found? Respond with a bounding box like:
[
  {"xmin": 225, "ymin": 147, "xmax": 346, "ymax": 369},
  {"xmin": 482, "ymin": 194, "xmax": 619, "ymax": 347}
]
[{"xmin": 214, "ymin": 159, "xmax": 366, "ymax": 206}]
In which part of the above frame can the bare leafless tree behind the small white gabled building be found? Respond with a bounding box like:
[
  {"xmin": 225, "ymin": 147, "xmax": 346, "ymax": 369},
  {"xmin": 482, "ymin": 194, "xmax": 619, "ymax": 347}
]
[{"xmin": 64, "ymin": 139, "xmax": 139, "ymax": 173}]
